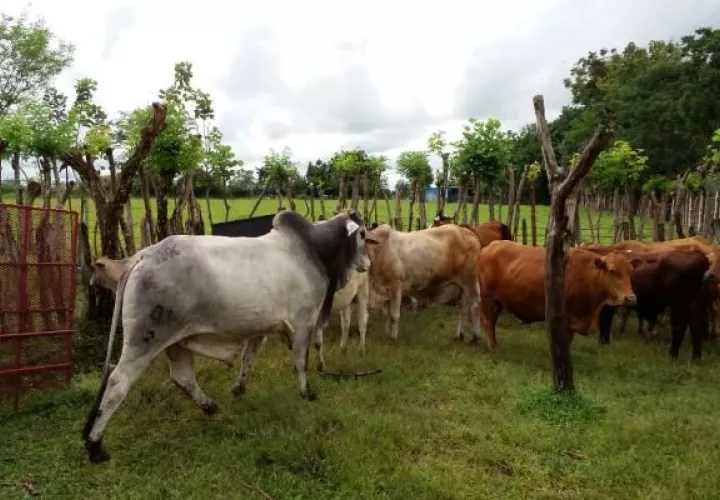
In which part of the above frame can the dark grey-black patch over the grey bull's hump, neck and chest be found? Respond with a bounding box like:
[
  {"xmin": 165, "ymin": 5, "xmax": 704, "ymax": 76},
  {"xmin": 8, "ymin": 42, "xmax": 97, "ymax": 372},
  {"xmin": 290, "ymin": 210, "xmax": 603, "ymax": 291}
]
[{"xmin": 273, "ymin": 210, "xmax": 365, "ymax": 328}]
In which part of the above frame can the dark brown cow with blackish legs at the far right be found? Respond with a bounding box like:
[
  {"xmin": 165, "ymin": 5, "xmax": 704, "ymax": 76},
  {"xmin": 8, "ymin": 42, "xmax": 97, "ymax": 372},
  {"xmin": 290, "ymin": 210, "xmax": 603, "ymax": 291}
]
[{"xmin": 598, "ymin": 248, "xmax": 710, "ymax": 359}]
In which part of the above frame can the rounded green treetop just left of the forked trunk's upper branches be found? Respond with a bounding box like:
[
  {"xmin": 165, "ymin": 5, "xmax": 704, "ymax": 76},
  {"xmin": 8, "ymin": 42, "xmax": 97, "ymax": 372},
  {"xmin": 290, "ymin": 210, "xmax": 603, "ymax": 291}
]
[{"xmin": 452, "ymin": 118, "xmax": 511, "ymax": 186}]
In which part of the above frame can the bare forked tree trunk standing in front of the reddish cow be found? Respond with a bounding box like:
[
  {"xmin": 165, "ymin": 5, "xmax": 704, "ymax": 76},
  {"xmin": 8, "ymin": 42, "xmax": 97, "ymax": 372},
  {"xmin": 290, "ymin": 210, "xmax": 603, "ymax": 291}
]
[{"xmin": 533, "ymin": 96, "xmax": 611, "ymax": 392}]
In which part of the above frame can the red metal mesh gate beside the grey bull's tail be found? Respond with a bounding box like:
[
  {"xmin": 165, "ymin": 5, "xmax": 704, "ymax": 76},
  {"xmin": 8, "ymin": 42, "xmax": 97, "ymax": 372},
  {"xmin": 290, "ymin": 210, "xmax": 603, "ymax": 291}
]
[{"xmin": 0, "ymin": 204, "xmax": 78, "ymax": 410}]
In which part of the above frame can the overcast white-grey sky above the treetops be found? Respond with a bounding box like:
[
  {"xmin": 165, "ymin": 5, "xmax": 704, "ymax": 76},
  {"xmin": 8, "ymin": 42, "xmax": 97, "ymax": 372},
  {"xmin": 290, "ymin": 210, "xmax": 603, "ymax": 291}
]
[{"xmin": 0, "ymin": 0, "xmax": 720, "ymax": 181}]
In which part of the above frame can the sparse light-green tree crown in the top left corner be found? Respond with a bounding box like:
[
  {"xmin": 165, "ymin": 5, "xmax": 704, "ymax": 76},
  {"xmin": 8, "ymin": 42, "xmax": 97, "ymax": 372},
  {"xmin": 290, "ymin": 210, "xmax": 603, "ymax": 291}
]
[{"xmin": 0, "ymin": 13, "xmax": 75, "ymax": 117}]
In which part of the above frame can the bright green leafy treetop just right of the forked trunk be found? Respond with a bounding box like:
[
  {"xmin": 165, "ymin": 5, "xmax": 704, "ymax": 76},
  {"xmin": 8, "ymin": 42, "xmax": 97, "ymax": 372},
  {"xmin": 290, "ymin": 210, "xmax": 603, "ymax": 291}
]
[{"xmin": 592, "ymin": 141, "xmax": 648, "ymax": 193}]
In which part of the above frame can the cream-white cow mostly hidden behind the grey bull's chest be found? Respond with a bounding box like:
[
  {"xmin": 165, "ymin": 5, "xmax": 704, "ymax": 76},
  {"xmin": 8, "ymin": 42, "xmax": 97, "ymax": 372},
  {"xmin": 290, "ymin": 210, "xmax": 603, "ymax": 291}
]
[{"xmin": 315, "ymin": 271, "xmax": 370, "ymax": 371}]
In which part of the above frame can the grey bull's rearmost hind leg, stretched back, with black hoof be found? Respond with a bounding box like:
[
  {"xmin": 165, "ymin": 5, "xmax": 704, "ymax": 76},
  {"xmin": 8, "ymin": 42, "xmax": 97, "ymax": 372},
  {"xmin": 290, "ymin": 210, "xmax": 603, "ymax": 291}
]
[{"xmin": 83, "ymin": 346, "xmax": 158, "ymax": 463}]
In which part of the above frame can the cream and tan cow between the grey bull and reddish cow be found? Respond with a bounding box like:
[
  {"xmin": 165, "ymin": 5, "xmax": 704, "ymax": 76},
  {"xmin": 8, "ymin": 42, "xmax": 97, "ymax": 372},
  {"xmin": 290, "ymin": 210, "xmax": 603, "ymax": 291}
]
[{"xmin": 366, "ymin": 224, "xmax": 480, "ymax": 341}]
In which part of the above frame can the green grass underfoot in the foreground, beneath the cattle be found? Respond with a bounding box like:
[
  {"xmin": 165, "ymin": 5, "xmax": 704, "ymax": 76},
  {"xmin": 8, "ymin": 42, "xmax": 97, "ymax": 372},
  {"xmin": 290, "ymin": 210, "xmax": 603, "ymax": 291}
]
[{"xmin": 0, "ymin": 308, "xmax": 720, "ymax": 500}]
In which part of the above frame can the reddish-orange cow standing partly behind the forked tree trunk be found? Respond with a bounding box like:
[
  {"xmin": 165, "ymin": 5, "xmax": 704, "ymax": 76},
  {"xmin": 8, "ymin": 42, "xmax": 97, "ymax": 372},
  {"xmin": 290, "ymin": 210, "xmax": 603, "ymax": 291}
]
[{"xmin": 477, "ymin": 241, "xmax": 635, "ymax": 348}]
